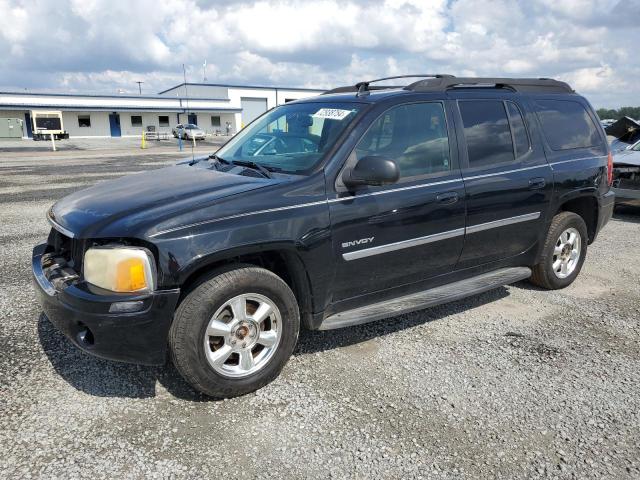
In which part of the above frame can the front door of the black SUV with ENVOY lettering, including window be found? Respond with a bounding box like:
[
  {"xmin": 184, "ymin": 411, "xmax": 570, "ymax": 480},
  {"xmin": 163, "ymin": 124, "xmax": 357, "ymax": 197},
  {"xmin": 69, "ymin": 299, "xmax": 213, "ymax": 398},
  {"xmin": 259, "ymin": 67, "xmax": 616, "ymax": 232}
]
[{"xmin": 329, "ymin": 101, "xmax": 465, "ymax": 302}]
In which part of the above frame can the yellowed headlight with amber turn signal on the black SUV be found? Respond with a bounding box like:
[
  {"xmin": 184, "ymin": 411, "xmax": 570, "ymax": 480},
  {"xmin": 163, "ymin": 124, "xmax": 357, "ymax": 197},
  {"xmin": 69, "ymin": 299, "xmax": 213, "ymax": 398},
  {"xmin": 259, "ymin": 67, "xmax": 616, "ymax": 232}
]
[{"xmin": 84, "ymin": 246, "xmax": 155, "ymax": 293}]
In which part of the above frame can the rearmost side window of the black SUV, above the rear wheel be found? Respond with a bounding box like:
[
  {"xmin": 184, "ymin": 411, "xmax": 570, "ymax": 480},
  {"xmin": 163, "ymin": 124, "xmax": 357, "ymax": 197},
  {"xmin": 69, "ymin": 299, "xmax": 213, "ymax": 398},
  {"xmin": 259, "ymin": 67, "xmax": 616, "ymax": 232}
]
[{"xmin": 535, "ymin": 100, "xmax": 602, "ymax": 150}]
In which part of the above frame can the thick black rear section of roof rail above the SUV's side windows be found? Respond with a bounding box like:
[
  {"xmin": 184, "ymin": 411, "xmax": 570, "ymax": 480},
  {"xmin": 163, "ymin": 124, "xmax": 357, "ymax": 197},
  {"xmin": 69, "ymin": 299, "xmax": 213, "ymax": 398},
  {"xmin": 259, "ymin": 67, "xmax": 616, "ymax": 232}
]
[{"xmin": 404, "ymin": 77, "xmax": 575, "ymax": 93}]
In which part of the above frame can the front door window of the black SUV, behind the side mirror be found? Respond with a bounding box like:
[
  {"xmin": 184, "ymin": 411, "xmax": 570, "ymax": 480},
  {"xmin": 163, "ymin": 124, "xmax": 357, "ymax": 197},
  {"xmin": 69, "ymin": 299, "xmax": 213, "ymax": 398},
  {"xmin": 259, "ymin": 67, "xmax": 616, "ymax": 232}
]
[{"xmin": 355, "ymin": 102, "xmax": 451, "ymax": 179}]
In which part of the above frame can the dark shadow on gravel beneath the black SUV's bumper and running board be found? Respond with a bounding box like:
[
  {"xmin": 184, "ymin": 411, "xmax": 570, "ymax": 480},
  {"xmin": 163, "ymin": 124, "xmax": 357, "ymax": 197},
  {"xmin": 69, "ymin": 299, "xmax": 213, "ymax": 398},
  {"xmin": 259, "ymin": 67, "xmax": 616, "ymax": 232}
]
[{"xmin": 38, "ymin": 287, "xmax": 509, "ymax": 402}]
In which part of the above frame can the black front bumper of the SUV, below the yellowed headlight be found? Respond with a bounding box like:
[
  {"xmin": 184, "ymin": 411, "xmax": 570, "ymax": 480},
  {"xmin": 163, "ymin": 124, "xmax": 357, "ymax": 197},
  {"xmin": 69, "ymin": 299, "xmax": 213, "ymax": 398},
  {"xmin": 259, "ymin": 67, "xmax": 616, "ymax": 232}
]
[{"xmin": 32, "ymin": 244, "xmax": 180, "ymax": 365}]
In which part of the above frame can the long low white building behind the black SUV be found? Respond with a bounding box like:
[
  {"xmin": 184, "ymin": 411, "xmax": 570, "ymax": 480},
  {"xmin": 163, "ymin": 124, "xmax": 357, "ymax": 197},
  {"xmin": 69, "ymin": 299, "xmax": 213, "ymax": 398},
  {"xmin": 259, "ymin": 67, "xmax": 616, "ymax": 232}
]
[{"xmin": 0, "ymin": 83, "xmax": 322, "ymax": 138}]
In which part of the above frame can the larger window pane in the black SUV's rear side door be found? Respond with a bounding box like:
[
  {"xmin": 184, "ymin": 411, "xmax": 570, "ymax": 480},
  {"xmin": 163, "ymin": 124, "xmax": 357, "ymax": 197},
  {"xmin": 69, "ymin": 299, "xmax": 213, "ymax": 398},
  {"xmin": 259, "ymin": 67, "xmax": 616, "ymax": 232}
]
[{"xmin": 458, "ymin": 100, "xmax": 516, "ymax": 168}]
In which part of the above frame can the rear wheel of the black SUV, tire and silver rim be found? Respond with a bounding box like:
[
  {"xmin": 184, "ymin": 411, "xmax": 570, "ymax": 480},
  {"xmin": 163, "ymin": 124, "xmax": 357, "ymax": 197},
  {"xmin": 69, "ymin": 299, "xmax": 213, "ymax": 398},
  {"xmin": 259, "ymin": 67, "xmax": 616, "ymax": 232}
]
[{"xmin": 530, "ymin": 212, "xmax": 589, "ymax": 290}]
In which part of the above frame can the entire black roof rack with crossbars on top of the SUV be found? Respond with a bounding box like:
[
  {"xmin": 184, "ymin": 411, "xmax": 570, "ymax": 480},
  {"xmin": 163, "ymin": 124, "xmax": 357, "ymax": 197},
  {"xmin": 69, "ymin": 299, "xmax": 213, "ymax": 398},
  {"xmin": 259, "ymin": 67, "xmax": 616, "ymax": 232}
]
[{"xmin": 324, "ymin": 74, "xmax": 575, "ymax": 95}]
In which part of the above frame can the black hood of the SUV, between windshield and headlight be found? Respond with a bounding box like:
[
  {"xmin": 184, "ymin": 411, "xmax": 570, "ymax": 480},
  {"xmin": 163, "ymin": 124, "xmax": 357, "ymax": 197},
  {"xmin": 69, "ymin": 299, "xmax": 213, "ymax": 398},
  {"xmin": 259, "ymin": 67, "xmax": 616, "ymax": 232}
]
[{"xmin": 49, "ymin": 164, "xmax": 274, "ymax": 238}]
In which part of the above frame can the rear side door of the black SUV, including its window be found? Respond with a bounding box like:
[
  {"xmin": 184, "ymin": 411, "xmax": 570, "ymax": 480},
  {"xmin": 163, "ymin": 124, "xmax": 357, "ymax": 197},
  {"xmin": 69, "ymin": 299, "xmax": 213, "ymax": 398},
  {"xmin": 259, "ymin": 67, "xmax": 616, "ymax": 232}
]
[{"xmin": 451, "ymin": 92, "xmax": 553, "ymax": 269}]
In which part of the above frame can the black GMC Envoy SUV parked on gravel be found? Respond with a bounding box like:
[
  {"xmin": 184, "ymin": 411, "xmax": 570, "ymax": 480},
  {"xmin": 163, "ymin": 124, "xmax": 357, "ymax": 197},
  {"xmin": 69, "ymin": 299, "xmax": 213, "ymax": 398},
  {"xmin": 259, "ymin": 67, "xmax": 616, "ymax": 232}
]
[{"xmin": 33, "ymin": 75, "xmax": 614, "ymax": 397}]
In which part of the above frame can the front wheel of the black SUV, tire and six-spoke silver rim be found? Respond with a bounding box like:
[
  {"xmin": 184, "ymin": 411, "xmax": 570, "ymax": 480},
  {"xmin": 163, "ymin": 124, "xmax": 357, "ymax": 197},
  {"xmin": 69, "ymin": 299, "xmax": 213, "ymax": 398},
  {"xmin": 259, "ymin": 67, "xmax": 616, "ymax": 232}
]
[{"xmin": 169, "ymin": 265, "xmax": 300, "ymax": 398}]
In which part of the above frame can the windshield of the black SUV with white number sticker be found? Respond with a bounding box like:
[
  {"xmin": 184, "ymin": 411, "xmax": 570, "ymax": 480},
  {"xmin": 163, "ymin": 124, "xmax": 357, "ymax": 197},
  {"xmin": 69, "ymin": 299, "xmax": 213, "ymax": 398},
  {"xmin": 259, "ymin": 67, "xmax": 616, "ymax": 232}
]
[{"xmin": 216, "ymin": 102, "xmax": 361, "ymax": 174}]
